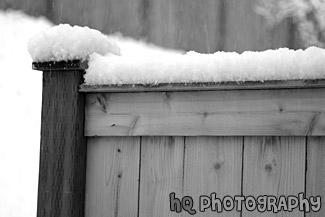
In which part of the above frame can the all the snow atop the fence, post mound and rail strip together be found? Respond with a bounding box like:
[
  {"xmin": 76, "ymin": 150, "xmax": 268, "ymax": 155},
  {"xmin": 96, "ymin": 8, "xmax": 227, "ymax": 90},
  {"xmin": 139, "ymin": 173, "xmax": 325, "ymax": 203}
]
[{"xmin": 28, "ymin": 24, "xmax": 325, "ymax": 85}]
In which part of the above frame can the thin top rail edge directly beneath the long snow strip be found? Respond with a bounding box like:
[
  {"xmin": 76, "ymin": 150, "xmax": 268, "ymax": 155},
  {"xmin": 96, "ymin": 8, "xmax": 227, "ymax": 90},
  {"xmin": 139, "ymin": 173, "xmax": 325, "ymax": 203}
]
[{"xmin": 79, "ymin": 79, "xmax": 325, "ymax": 93}]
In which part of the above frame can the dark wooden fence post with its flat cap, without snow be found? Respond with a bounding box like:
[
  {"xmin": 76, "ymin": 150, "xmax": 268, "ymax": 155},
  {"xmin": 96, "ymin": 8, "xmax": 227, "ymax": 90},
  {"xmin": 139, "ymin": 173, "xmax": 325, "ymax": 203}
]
[{"xmin": 33, "ymin": 61, "xmax": 87, "ymax": 217}]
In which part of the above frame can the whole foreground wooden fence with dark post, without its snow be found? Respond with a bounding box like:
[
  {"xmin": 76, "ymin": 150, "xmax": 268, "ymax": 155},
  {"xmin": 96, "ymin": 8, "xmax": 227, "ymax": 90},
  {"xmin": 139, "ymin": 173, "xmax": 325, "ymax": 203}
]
[{"xmin": 34, "ymin": 61, "xmax": 325, "ymax": 217}]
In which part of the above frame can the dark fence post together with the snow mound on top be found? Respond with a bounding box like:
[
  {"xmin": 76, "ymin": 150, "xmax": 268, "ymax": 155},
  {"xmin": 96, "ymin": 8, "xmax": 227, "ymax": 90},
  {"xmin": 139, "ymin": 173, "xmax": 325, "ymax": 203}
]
[{"xmin": 28, "ymin": 25, "xmax": 119, "ymax": 217}]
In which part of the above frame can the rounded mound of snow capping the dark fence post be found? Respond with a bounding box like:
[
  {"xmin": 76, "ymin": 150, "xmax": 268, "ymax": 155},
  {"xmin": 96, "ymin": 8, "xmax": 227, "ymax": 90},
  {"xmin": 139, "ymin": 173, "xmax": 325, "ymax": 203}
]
[{"xmin": 28, "ymin": 24, "xmax": 120, "ymax": 62}]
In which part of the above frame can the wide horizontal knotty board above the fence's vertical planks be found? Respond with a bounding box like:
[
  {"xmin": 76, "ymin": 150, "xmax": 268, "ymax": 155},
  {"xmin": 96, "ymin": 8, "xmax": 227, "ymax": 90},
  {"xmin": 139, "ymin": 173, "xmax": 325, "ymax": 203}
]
[{"xmin": 85, "ymin": 88, "xmax": 325, "ymax": 136}]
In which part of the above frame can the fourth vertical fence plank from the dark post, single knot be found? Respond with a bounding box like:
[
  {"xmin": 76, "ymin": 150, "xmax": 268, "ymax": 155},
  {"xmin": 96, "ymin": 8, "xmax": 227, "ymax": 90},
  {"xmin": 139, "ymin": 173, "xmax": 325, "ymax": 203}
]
[{"xmin": 243, "ymin": 137, "xmax": 306, "ymax": 217}]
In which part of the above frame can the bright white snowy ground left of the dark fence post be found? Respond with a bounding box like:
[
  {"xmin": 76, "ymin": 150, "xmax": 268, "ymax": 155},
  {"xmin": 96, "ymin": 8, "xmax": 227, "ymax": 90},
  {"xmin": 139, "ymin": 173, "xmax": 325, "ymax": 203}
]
[{"xmin": 0, "ymin": 10, "xmax": 52, "ymax": 217}]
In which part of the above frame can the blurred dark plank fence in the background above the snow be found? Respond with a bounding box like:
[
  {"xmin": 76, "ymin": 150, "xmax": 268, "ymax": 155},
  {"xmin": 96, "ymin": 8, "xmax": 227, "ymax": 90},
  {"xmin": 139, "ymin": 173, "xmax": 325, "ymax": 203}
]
[{"xmin": 0, "ymin": 0, "xmax": 299, "ymax": 53}]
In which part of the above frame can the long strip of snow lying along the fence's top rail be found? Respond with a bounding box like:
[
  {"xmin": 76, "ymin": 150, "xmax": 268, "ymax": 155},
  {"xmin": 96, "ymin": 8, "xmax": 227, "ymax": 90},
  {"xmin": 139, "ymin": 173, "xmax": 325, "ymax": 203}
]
[{"xmin": 85, "ymin": 47, "xmax": 325, "ymax": 85}]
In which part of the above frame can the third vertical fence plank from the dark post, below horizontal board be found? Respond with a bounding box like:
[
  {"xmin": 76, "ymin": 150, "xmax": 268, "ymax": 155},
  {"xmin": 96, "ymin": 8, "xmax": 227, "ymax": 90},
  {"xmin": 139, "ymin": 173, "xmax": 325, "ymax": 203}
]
[{"xmin": 184, "ymin": 137, "xmax": 243, "ymax": 217}]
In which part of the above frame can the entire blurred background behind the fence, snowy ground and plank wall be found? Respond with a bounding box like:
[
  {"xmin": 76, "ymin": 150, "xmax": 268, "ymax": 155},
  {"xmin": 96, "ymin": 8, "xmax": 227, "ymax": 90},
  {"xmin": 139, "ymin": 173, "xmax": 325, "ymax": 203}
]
[{"xmin": 0, "ymin": 0, "xmax": 325, "ymax": 217}]
